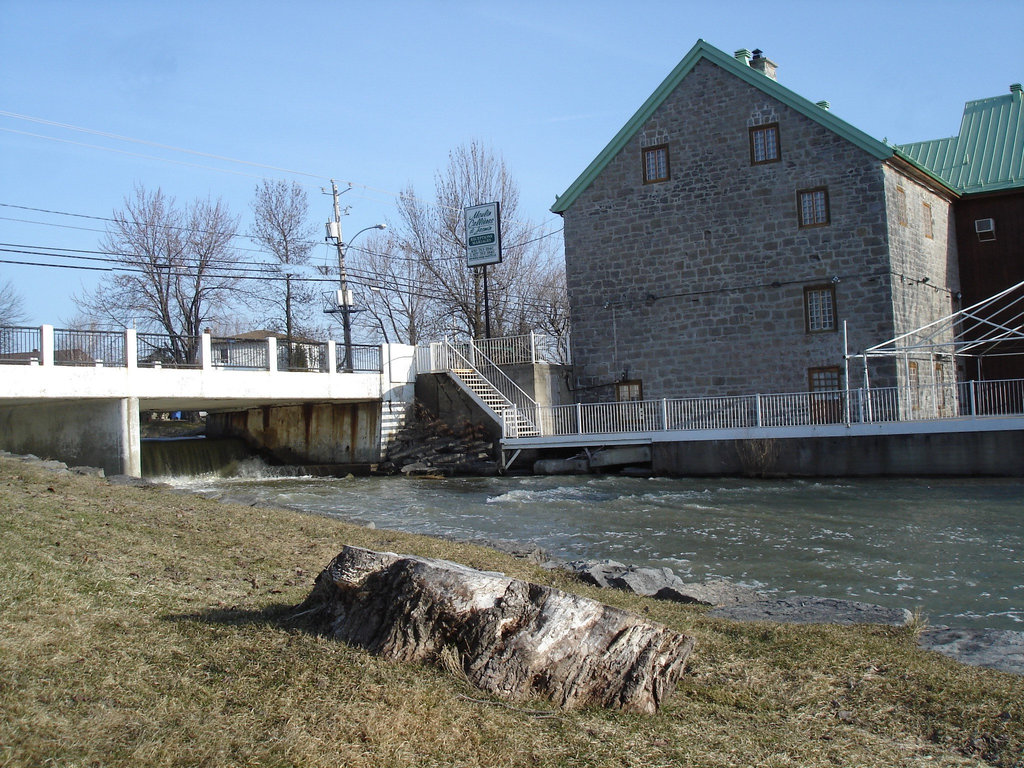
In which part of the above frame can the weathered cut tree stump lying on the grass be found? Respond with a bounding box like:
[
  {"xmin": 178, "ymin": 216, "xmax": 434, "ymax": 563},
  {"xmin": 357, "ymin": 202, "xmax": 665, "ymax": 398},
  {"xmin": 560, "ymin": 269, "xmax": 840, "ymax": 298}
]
[{"xmin": 300, "ymin": 547, "xmax": 694, "ymax": 714}]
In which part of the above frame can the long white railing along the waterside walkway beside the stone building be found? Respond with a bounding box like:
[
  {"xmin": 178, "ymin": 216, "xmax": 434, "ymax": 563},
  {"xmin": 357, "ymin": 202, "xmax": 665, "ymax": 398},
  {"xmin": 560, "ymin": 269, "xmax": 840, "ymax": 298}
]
[{"xmin": 503, "ymin": 379, "xmax": 1024, "ymax": 438}]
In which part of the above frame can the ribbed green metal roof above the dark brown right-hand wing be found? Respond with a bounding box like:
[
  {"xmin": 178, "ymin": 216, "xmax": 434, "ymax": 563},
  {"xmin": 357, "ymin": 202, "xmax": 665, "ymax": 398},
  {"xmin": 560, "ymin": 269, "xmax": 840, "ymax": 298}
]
[{"xmin": 898, "ymin": 84, "xmax": 1024, "ymax": 194}]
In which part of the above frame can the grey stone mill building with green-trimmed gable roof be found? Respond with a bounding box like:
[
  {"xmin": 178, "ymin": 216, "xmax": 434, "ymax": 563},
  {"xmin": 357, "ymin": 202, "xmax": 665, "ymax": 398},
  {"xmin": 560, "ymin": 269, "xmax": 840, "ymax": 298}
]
[{"xmin": 552, "ymin": 41, "xmax": 961, "ymax": 401}]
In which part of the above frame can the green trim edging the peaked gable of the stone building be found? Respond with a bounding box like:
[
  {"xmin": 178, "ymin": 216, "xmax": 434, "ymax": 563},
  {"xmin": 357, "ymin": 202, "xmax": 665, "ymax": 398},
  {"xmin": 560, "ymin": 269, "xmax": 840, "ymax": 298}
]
[{"xmin": 551, "ymin": 40, "xmax": 894, "ymax": 213}]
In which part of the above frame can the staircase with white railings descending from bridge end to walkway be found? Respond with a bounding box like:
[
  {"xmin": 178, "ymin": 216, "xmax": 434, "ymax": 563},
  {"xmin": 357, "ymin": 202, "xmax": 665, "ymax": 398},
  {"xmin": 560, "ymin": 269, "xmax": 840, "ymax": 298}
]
[{"xmin": 418, "ymin": 340, "xmax": 541, "ymax": 437}]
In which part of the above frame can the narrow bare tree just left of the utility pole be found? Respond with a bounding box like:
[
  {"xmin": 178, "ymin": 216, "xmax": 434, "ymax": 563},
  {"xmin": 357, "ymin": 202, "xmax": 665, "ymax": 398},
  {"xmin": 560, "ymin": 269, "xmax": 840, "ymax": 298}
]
[{"xmin": 250, "ymin": 179, "xmax": 318, "ymax": 365}]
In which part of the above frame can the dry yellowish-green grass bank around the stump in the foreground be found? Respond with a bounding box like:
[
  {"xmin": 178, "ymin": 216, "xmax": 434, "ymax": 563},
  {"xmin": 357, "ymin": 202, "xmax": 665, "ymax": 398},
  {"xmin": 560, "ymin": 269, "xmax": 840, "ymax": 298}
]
[{"xmin": 0, "ymin": 459, "xmax": 1024, "ymax": 768}]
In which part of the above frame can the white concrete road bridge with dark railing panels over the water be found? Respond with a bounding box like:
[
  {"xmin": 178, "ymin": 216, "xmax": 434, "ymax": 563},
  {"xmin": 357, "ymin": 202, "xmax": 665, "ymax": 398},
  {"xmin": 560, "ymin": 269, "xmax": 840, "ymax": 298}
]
[{"xmin": 0, "ymin": 326, "xmax": 416, "ymax": 475}]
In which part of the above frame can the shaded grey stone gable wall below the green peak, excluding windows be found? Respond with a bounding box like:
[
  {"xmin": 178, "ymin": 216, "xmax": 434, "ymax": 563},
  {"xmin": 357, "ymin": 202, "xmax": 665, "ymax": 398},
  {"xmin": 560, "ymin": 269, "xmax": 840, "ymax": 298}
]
[{"xmin": 564, "ymin": 60, "xmax": 913, "ymax": 400}]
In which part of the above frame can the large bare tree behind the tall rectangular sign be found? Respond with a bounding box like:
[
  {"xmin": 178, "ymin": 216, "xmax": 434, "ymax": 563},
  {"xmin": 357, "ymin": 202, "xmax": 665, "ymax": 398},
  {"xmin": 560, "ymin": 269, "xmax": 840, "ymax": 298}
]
[{"xmin": 364, "ymin": 142, "xmax": 564, "ymax": 337}]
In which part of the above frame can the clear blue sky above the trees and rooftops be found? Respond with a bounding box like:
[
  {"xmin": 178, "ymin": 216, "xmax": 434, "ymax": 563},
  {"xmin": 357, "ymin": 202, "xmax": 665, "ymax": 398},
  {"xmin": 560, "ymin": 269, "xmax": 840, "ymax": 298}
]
[{"xmin": 0, "ymin": 0, "xmax": 1024, "ymax": 326}]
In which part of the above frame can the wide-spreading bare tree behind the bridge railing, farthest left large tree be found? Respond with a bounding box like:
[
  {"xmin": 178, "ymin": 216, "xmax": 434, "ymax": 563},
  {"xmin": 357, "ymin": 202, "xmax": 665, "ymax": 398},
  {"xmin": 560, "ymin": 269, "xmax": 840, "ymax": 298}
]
[{"xmin": 75, "ymin": 185, "xmax": 239, "ymax": 361}]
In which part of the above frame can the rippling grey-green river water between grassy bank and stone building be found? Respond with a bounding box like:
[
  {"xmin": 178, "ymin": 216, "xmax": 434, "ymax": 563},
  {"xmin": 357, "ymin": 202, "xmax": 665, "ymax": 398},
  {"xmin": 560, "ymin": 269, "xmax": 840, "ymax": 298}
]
[{"xmin": 159, "ymin": 456, "xmax": 1024, "ymax": 631}]
